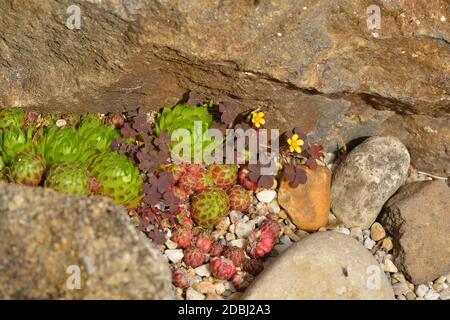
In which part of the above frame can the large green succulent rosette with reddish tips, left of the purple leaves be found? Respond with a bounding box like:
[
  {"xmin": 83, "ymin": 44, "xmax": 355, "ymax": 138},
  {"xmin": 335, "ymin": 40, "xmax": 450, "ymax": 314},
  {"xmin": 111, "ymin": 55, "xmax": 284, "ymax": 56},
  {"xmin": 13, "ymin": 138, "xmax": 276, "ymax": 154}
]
[{"xmin": 89, "ymin": 152, "xmax": 143, "ymax": 208}]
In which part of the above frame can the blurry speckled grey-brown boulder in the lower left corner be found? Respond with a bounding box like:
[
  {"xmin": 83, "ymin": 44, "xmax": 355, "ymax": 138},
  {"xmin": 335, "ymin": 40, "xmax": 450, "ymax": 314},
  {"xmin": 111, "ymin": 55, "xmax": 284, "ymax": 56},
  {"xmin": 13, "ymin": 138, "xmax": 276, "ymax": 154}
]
[{"xmin": 0, "ymin": 183, "xmax": 174, "ymax": 299}]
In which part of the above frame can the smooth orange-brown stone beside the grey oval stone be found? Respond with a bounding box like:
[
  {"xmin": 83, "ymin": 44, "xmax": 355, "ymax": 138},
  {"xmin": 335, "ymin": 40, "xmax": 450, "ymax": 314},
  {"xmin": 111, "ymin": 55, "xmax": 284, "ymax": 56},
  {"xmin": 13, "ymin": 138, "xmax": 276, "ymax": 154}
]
[{"xmin": 278, "ymin": 166, "xmax": 331, "ymax": 231}]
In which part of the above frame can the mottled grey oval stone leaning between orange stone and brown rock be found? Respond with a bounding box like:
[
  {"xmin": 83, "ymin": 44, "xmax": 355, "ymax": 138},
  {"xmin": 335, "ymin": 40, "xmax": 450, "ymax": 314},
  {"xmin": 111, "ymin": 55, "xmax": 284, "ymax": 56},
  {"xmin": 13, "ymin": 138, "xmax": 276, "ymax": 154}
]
[{"xmin": 331, "ymin": 136, "xmax": 410, "ymax": 229}]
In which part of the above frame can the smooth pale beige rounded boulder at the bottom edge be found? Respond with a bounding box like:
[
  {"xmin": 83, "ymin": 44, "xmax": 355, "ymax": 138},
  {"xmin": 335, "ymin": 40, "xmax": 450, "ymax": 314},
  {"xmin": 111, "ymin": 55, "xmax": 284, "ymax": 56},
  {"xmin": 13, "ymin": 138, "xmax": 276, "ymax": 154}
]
[{"xmin": 243, "ymin": 231, "xmax": 394, "ymax": 300}]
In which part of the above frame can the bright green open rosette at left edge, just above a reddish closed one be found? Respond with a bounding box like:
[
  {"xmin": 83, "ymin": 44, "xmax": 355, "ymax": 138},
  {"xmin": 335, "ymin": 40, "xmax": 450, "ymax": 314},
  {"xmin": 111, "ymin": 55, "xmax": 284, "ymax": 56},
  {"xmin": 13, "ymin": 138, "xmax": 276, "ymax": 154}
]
[{"xmin": 0, "ymin": 126, "xmax": 35, "ymax": 165}]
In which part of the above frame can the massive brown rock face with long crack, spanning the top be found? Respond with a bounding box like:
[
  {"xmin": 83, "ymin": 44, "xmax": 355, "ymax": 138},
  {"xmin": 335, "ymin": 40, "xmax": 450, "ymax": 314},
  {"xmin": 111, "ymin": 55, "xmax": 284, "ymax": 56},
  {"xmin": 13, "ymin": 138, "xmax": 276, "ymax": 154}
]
[{"xmin": 0, "ymin": 0, "xmax": 450, "ymax": 176}]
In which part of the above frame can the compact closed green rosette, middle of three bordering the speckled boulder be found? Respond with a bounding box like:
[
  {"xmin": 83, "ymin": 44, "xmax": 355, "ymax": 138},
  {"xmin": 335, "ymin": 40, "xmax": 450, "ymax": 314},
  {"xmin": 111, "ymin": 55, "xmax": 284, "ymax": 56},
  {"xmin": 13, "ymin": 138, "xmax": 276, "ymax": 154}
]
[{"xmin": 44, "ymin": 163, "xmax": 90, "ymax": 196}]
